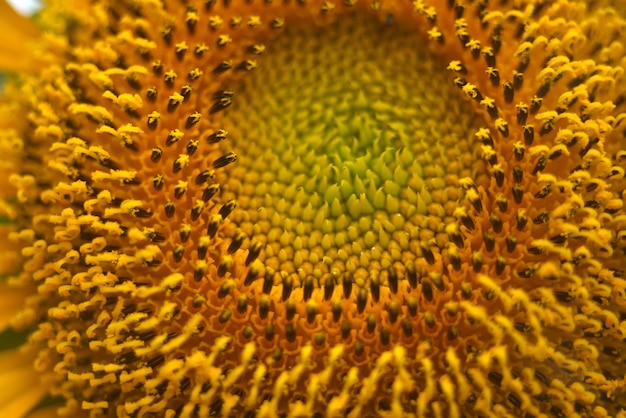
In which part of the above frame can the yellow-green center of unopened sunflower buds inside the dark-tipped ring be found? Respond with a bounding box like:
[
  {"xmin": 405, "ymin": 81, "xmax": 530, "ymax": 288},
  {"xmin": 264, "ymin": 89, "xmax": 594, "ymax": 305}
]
[{"xmin": 217, "ymin": 16, "xmax": 479, "ymax": 285}]
